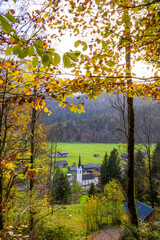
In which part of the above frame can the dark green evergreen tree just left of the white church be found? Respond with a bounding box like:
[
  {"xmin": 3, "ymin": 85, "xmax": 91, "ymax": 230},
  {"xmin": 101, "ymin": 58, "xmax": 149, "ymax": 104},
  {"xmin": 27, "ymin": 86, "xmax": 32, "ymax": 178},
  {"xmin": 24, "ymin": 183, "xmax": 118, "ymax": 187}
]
[{"xmin": 52, "ymin": 167, "xmax": 70, "ymax": 203}]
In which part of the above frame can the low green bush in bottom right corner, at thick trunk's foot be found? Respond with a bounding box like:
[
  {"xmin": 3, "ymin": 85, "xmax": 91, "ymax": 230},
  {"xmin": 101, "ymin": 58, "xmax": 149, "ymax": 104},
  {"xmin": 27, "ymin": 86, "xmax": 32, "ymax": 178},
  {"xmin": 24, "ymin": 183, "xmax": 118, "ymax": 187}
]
[{"xmin": 122, "ymin": 223, "xmax": 160, "ymax": 240}]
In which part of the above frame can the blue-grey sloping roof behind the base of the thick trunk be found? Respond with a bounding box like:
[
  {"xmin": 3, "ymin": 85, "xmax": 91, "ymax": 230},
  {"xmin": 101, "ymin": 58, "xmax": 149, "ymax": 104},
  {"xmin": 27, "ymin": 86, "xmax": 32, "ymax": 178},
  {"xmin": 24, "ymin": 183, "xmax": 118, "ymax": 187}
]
[{"xmin": 124, "ymin": 200, "xmax": 154, "ymax": 220}]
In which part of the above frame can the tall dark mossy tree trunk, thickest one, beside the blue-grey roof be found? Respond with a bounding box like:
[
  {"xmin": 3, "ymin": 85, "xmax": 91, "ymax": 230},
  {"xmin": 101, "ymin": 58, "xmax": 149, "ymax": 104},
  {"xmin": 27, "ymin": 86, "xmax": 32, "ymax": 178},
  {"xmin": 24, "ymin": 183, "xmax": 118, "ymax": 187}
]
[{"xmin": 125, "ymin": 10, "xmax": 138, "ymax": 226}]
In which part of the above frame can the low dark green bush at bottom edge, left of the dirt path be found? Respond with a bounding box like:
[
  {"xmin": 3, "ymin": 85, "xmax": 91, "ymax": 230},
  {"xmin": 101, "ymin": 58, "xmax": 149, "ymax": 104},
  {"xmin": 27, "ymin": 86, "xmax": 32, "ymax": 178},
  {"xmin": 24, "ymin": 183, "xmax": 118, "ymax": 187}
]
[{"xmin": 42, "ymin": 224, "xmax": 76, "ymax": 240}]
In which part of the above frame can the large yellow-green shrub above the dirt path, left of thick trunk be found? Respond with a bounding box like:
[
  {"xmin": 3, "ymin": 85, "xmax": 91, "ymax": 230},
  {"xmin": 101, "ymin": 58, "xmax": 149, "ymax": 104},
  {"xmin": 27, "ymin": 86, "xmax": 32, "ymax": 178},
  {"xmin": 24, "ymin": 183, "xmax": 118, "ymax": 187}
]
[{"xmin": 84, "ymin": 179, "xmax": 124, "ymax": 232}]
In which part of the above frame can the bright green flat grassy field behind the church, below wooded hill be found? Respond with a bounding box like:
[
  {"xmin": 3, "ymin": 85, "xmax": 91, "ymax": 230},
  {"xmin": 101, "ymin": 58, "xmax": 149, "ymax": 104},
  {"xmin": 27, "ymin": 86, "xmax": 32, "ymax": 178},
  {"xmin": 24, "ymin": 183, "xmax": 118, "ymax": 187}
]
[{"xmin": 48, "ymin": 143, "xmax": 126, "ymax": 166}]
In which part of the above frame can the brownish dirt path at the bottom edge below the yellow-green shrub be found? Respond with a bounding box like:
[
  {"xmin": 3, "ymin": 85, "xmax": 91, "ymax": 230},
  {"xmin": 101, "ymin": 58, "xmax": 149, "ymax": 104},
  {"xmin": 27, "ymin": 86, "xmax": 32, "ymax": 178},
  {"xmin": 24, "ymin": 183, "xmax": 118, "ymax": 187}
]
[{"xmin": 87, "ymin": 228, "xmax": 121, "ymax": 240}]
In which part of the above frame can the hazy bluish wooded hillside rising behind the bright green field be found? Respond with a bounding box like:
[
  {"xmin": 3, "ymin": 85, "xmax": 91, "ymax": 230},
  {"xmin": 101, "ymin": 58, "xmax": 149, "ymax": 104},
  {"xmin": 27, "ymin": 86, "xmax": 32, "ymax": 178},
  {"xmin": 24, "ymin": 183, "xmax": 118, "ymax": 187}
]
[{"xmin": 41, "ymin": 93, "xmax": 160, "ymax": 143}]
